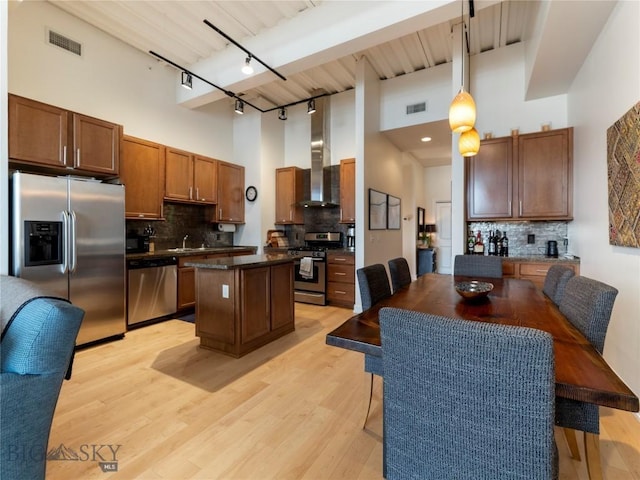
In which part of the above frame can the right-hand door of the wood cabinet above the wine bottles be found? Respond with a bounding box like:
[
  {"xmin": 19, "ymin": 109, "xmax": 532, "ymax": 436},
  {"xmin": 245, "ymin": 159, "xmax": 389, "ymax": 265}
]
[{"xmin": 517, "ymin": 128, "xmax": 573, "ymax": 220}]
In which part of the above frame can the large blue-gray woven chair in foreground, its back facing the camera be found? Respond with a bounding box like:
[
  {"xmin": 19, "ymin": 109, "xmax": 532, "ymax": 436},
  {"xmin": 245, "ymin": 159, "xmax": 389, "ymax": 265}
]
[{"xmin": 379, "ymin": 308, "xmax": 557, "ymax": 480}]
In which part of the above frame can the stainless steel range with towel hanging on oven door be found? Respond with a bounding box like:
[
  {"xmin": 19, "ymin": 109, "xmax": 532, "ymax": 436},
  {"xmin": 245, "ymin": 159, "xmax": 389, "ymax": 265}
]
[{"xmin": 288, "ymin": 232, "xmax": 342, "ymax": 305}]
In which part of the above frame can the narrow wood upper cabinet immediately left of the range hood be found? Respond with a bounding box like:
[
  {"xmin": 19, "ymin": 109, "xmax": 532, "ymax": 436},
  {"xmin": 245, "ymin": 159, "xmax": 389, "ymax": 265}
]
[{"xmin": 275, "ymin": 167, "xmax": 304, "ymax": 225}]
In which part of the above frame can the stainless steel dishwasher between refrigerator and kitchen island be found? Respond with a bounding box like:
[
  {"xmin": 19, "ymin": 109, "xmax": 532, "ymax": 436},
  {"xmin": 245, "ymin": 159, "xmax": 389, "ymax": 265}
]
[{"xmin": 127, "ymin": 257, "xmax": 178, "ymax": 326}]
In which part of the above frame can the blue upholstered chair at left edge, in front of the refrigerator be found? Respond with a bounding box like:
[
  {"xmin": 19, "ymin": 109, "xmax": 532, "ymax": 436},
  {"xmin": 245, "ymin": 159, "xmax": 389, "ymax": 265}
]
[{"xmin": 0, "ymin": 276, "xmax": 84, "ymax": 480}]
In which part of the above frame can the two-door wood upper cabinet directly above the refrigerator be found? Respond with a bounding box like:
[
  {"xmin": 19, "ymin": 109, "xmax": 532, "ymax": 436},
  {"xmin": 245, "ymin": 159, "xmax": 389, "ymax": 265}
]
[{"xmin": 9, "ymin": 95, "xmax": 122, "ymax": 176}]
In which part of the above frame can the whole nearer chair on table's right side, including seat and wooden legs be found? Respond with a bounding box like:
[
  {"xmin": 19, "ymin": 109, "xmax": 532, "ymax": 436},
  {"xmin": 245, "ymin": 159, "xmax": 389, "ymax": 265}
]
[{"xmin": 556, "ymin": 276, "xmax": 618, "ymax": 472}]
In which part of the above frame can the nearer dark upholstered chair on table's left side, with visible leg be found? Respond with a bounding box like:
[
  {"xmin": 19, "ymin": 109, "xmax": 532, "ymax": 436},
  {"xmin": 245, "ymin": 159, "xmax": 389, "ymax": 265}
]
[{"xmin": 356, "ymin": 263, "xmax": 391, "ymax": 428}]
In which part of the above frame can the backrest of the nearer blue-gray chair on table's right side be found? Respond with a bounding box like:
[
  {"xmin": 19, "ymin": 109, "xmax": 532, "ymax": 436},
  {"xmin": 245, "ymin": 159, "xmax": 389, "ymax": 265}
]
[{"xmin": 560, "ymin": 276, "xmax": 618, "ymax": 353}]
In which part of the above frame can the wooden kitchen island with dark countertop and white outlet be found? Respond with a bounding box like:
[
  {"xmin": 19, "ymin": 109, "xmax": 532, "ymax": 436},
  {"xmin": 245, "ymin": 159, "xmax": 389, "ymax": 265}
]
[{"xmin": 185, "ymin": 254, "xmax": 295, "ymax": 357}]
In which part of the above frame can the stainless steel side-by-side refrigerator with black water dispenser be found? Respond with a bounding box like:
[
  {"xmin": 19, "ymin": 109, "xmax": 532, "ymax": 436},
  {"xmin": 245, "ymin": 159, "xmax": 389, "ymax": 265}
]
[{"xmin": 11, "ymin": 172, "xmax": 126, "ymax": 345}]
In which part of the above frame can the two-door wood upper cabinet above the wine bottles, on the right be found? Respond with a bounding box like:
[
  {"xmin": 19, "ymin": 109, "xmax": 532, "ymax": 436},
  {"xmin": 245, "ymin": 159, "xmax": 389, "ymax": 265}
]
[{"xmin": 465, "ymin": 128, "xmax": 573, "ymax": 221}]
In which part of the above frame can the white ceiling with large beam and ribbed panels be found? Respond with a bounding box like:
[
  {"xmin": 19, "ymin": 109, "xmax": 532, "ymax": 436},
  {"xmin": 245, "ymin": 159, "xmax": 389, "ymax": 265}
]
[{"xmin": 48, "ymin": 0, "xmax": 615, "ymax": 165}]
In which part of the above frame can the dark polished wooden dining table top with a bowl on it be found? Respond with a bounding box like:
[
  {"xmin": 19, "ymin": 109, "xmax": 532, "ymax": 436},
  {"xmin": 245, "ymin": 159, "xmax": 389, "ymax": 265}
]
[{"xmin": 326, "ymin": 273, "xmax": 638, "ymax": 412}]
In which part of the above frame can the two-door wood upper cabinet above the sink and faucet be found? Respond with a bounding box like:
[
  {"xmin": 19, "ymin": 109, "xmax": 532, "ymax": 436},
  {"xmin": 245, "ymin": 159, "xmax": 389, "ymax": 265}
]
[{"xmin": 164, "ymin": 147, "xmax": 218, "ymax": 204}]
